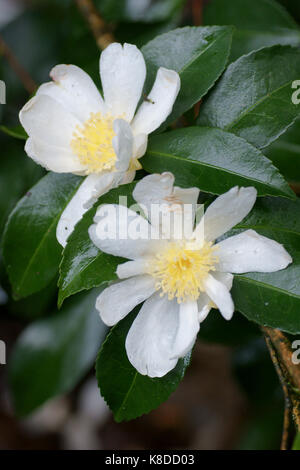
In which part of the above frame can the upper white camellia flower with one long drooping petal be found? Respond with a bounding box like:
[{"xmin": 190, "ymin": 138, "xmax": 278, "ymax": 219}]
[{"xmin": 20, "ymin": 43, "xmax": 180, "ymax": 246}]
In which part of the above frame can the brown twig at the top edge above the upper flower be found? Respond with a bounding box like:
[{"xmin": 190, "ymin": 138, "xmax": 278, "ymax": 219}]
[{"xmin": 75, "ymin": 0, "xmax": 115, "ymax": 51}]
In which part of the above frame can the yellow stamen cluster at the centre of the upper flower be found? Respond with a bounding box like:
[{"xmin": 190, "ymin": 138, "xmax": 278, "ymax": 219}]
[{"xmin": 71, "ymin": 113, "xmax": 117, "ymax": 174}]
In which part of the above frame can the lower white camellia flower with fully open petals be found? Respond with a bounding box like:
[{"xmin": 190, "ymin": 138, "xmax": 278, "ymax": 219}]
[{"xmin": 89, "ymin": 173, "xmax": 292, "ymax": 377}]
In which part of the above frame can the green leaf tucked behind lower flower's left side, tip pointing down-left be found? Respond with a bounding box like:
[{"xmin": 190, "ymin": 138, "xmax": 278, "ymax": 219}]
[{"xmin": 58, "ymin": 183, "xmax": 135, "ymax": 306}]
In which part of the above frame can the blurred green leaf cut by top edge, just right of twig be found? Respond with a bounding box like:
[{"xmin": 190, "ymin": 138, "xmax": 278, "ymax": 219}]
[{"xmin": 95, "ymin": 0, "xmax": 184, "ymax": 23}]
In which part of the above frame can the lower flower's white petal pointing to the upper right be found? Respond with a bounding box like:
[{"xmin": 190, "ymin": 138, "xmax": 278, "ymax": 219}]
[{"xmin": 200, "ymin": 186, "xmax": 257, "ymax": 240}]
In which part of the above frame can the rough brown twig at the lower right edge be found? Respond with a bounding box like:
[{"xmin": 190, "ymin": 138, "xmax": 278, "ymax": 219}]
[{"xmin": 262, "ymin": 327, "xmax": 300, "ymax": 450}]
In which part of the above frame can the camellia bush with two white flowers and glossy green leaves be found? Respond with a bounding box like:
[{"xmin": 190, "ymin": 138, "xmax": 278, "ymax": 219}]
[{"xmin": 1, "ymin": 0, "xmax": 300, "ymax": 448}]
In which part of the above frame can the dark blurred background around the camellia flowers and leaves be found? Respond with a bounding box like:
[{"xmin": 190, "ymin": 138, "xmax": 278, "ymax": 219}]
[{"xmin": 0, "ymin": 0, "xmax": 300, "ymax": 449}]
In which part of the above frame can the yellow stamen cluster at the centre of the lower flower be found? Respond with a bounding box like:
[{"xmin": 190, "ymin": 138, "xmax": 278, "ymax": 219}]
[{"xmin": 149, "ymin": 241, "xmax": 218, "ymax": 303}]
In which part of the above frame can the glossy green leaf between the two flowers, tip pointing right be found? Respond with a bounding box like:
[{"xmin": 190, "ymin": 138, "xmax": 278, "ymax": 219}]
[{"xmin": 141, "ymin": 127, "xmax": 295, "ymax": 198}]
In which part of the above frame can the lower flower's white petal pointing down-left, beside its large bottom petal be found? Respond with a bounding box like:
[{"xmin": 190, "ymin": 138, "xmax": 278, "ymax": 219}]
[{"xmin": 96, "ymin": 276, "xmax": 155, "ymax": 326}]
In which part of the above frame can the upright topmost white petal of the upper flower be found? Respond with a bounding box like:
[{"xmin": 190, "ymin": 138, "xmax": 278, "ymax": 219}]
[{"xmin": 100, "ymin": 43, "xmax": 146, "ymax": 122}]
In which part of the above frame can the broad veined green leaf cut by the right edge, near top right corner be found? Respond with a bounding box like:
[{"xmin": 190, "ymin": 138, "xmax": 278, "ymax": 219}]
[{"xmin": 198, "ymin": 46, "xmax": 300, "ymax": 148}]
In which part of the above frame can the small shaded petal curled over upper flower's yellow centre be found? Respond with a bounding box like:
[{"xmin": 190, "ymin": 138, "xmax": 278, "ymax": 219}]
[{"xmin": 112, "ymin": 119, "xmax": 133, "ymax": 172}]
